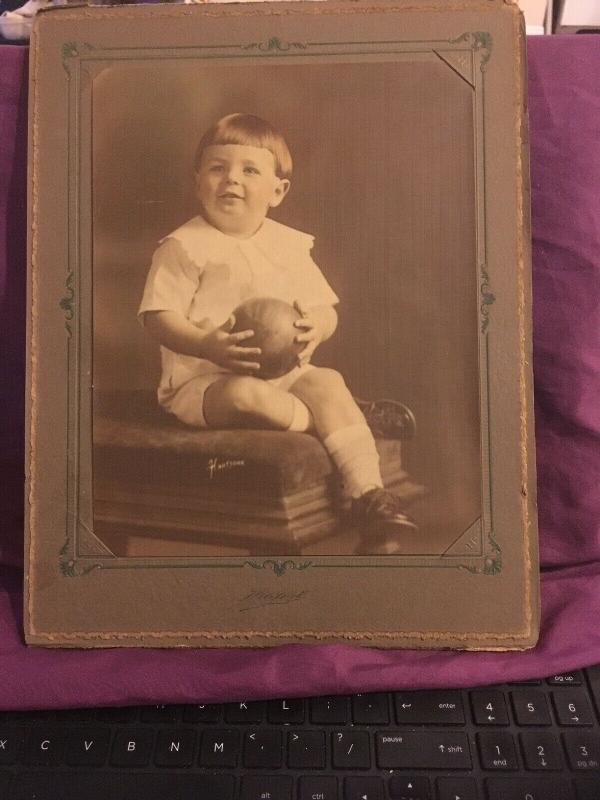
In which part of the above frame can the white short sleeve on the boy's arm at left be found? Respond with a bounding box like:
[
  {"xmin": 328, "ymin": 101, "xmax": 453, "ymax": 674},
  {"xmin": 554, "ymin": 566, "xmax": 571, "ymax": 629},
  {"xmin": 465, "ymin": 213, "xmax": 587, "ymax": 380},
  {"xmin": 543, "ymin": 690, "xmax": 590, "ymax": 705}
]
[{"xmin": 138, "ymin": 237, "xmax": 202, "ymax": 323}]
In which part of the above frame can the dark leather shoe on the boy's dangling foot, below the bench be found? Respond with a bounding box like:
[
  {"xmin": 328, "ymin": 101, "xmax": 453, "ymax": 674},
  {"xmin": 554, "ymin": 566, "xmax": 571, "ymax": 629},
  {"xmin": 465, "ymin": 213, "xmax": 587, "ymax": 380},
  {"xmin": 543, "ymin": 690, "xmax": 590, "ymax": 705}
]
[{"xmin": 351, "ymin": 489, "xmax": 418, "ymax": 555}]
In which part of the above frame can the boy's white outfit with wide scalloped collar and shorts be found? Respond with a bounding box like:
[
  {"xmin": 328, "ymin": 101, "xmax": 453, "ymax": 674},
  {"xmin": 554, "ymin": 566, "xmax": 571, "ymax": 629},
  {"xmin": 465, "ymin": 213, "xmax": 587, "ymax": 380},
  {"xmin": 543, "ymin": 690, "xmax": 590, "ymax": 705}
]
[{"xmin": 138, "ymin": 216, "xmax": 339, "ymax": 427}]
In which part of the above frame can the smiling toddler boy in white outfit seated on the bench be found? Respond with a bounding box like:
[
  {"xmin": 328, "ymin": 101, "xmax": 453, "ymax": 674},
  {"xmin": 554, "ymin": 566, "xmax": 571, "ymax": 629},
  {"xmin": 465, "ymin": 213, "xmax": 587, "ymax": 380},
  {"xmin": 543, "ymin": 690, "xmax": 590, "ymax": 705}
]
[{"xmin": 139, "ymin": 114, "xmax": 416, "ymax": 555}]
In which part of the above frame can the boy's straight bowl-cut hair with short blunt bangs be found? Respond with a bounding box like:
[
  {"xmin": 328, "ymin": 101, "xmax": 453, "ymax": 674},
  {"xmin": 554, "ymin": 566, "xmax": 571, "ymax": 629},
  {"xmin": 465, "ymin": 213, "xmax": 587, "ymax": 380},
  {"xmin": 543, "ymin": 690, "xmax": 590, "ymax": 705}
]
[{"xmin": 194, "ymin": 114, "xmax": 292, "ymax": 178}]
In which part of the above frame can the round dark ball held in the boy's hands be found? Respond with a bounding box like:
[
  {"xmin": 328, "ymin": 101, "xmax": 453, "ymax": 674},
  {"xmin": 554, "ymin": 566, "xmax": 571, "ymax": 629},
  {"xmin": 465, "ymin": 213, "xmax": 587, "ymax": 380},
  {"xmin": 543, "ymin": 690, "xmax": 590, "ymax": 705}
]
[{"xmin": 231, "ymin": 297, "xmax": 306, "ymax": 378}]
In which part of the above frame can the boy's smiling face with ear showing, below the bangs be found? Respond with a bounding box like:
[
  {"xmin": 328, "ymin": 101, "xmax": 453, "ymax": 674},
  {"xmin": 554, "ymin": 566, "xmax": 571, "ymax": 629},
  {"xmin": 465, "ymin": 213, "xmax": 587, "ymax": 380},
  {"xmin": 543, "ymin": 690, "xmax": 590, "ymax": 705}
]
[{"xmin": 196, "ymin": 144, "xmax": 290, "ymax": 238}]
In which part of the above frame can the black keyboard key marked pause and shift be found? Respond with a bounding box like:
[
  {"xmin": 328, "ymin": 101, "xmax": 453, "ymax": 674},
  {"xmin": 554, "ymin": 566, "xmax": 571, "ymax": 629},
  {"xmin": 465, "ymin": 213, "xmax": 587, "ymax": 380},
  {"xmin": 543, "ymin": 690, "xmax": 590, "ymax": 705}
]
[{"xmin": 376, "ymin": 730, "xmax": 472, "ymax": 769}]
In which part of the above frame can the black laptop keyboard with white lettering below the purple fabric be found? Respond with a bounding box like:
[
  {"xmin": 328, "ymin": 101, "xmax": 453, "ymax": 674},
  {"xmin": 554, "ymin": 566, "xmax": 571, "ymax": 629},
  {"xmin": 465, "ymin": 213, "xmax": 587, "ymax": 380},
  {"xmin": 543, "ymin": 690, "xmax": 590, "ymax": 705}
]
[{"xmin": 0, "ymin": 665, "xmax": 600, "ymax": 800}]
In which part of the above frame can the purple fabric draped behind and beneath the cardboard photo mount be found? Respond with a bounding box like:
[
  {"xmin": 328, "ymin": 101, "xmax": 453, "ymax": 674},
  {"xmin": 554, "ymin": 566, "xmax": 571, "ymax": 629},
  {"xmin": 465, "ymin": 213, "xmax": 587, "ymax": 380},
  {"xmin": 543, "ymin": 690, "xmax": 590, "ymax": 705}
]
[{"xmin": 0, "ymin": 36, "xmax": 600, "ymax": 709}]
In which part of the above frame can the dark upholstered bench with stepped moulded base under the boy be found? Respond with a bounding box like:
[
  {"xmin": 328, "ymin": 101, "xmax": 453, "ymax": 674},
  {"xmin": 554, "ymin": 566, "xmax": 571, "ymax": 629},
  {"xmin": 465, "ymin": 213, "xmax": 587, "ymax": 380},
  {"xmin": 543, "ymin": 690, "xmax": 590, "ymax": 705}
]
[{"xmin": 93, "ymin": 392, "xmax": 418, "ymax": 556}]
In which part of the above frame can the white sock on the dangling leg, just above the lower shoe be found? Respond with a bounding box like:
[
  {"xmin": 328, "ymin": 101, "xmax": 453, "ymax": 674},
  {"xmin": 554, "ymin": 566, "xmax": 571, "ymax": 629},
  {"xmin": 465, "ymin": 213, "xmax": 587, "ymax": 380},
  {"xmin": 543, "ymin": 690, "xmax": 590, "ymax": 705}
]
[{"xmin": 323, "ymin": 422, "xmax": 383, "ymax": 497}]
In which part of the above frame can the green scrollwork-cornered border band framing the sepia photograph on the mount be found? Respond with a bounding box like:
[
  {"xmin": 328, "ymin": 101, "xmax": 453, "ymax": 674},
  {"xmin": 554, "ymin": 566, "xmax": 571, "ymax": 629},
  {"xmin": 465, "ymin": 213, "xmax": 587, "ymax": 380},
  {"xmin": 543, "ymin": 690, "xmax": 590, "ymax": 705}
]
[{"xmin": 58, "ymin": 31, "xmax": 502, "ymax": 578}]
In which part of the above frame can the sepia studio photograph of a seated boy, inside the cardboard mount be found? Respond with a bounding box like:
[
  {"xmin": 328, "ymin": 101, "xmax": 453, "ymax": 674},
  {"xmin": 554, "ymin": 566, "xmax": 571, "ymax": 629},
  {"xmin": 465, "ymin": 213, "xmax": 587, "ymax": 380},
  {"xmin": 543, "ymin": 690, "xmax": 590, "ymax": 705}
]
[{"xmin": 91, "ymin": 56, "xmax": 484, "ymax": 559}]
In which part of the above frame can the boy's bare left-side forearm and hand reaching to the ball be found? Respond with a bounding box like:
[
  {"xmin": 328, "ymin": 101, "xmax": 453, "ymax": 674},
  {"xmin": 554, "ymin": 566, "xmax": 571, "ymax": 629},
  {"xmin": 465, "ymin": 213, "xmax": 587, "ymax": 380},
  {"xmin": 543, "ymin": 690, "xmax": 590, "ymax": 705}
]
[{"xmin": 144, "ymin": 311, "xmax": 261, "ymax": 375}]
